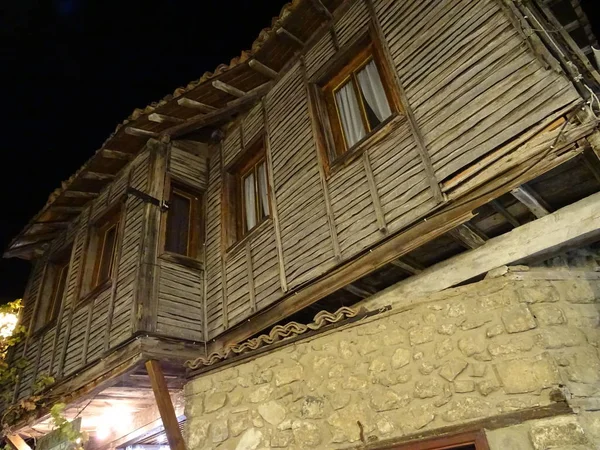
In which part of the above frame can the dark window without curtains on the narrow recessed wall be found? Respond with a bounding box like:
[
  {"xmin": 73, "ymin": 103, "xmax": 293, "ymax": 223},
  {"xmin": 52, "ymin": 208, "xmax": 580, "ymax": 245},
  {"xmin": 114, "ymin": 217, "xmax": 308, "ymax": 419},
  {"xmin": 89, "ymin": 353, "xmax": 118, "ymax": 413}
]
[{"xmin": 165, "ymin": 184, "xmax": 202, "ymax": 258}]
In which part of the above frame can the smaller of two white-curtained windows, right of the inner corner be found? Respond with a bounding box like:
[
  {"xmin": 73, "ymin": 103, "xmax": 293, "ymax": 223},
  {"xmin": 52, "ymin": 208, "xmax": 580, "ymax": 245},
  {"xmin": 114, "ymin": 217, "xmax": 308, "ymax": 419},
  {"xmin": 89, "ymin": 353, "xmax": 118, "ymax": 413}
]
[{"xmin": 225, "ymin": 137, "xmax": 271, "ymax": 245}]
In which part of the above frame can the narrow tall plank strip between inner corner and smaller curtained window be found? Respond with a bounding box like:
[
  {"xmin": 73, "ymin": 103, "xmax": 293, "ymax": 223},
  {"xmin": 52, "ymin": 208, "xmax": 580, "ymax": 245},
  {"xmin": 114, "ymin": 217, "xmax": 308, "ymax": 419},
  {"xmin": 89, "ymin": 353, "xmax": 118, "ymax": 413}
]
[{"xmin": 205, "ymin": 147, "xmax": 225, "ymax": 338}]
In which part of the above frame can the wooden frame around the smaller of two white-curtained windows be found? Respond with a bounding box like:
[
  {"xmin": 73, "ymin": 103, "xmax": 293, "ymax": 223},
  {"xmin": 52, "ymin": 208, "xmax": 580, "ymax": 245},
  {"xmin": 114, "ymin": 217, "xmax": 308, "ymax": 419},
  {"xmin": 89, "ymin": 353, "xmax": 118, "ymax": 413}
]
[{"xmin": 223, "ymin": 135, "xmax": 273, "ymax": 251}]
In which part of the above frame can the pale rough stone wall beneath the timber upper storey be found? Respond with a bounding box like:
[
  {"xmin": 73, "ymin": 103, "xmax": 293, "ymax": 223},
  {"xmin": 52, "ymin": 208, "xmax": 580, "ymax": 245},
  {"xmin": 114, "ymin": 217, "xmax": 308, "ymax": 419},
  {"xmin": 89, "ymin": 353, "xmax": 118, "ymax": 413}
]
[{"xmin": 185, "ymin": 277, "xmax": 600, "ymax": 450}]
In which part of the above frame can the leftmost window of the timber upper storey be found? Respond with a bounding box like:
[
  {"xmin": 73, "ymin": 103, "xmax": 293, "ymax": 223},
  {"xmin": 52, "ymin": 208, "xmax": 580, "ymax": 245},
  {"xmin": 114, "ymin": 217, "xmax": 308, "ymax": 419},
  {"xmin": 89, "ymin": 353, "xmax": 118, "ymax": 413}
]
[{"xmin": 34, "ymin": 251, "xmax": 71, "ymax": 332}]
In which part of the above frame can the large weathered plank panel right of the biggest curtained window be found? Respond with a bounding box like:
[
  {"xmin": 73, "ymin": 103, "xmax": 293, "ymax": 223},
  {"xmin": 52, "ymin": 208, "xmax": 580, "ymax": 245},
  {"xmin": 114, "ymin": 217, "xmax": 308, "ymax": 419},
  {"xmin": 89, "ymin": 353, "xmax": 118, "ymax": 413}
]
[{"xmin": 374, "ymin": 0, "xmax": 578, "ymax": 181}]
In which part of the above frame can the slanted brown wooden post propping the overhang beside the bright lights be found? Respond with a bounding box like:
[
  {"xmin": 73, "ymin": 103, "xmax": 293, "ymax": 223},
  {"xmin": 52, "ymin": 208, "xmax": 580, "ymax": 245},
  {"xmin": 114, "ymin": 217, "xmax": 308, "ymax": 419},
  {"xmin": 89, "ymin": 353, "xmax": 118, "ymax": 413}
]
[{"xmin": 146, "ymin": 359, "xmax": 185, "ymax": 450}]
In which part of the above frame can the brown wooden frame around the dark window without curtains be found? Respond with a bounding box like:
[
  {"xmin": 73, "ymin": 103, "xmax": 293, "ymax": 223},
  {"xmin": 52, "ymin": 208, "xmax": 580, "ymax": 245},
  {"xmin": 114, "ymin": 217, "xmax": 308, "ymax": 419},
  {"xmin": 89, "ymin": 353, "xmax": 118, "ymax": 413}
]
[{"xmin": 160, "ymin": 175, "xmax": 204, "ymax": 266}]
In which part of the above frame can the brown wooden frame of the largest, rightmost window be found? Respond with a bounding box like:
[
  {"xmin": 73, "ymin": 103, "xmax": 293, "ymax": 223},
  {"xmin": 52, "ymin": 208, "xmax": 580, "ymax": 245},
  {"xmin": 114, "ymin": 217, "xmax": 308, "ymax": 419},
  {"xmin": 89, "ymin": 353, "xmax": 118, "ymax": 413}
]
[{"xmin": 308, "ymin": 25, "xmax": 403, "ymax": 174}]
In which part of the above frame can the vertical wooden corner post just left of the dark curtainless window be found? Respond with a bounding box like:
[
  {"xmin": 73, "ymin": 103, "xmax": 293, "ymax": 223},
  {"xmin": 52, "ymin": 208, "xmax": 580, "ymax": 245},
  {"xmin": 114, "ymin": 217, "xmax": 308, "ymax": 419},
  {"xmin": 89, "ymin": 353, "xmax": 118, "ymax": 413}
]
[{"xmin": 133, "ymin": 139, "xmax": 167, "ymax": 332}]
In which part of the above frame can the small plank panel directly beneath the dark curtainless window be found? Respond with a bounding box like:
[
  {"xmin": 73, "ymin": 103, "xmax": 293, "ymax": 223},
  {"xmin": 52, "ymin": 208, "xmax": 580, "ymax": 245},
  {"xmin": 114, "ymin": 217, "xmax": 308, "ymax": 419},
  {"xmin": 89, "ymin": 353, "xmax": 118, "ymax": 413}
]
[{"xmin": 156, "ymin": 260, "xmax": 204, "ymax": 341}]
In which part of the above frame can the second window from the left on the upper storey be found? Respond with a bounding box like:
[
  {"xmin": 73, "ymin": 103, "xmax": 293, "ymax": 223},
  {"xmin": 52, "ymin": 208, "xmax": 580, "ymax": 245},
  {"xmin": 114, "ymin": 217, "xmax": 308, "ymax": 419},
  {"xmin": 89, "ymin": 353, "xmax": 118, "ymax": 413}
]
[{"xmin": 89, "ymin": 213, "xmax": 119, "ymax": 289}]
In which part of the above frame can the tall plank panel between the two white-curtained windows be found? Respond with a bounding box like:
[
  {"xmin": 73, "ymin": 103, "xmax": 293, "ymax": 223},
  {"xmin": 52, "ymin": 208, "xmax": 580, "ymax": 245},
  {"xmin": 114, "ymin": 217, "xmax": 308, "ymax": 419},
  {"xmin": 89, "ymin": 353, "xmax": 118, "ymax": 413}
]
[{"xmin": 266, "ymin": 64, "xmax": 335, "ymax": 287}]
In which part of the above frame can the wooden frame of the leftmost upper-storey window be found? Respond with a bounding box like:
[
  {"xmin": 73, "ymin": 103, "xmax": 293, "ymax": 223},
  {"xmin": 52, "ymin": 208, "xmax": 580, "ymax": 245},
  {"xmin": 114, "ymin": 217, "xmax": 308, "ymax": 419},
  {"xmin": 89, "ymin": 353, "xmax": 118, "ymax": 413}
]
[{"xmin": 32, "ymin": 247, "xmax": 71, "ymax": 334}]
